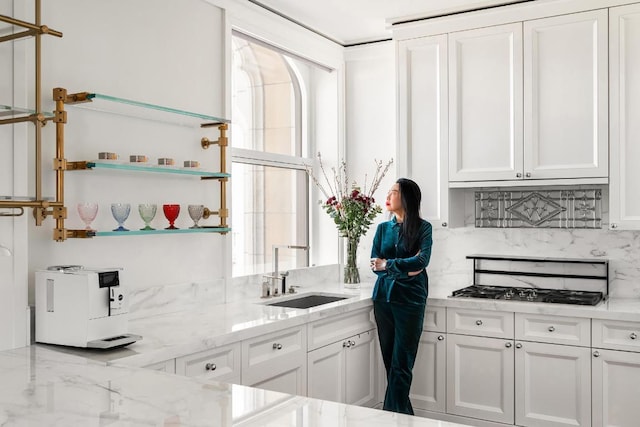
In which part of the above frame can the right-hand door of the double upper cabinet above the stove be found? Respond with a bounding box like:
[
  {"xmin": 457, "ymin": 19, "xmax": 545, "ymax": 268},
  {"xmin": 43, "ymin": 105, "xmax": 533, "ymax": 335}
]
[{"xmin": 524, "ymin": 10, "xmax": 608, "ymax": 179}]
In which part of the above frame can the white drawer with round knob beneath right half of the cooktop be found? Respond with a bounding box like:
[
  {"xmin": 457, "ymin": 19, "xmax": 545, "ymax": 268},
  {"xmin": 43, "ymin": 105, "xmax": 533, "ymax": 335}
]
[{"xmin": 516, "ymin": 313, "xmax": 591, "ymax": 347}]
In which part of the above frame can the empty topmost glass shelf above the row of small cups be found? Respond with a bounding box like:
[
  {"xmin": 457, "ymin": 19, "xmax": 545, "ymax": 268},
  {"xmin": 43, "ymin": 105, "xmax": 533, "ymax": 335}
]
[{"xmin": 69, "ymin": 93, "xmax": 230, "ymax": 127}]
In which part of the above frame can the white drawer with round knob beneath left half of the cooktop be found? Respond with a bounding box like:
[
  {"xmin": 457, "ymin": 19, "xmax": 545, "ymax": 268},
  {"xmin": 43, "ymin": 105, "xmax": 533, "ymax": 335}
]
[{"xmin": 447, "ymin": 308, "xmax": 513, "ymax": 338}]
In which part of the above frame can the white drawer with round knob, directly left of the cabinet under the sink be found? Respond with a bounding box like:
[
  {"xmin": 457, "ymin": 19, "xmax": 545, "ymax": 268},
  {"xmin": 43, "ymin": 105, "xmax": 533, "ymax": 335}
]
[{"xmin": 242, "ymin": 326, "xmax": 307, "ymax": 384}]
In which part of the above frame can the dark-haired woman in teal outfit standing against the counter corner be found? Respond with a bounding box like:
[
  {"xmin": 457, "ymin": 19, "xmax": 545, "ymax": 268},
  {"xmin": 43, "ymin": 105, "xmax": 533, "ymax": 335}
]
[{"xmin": 371, "ymin": 178, "xmax": 433, "ymax": 415}]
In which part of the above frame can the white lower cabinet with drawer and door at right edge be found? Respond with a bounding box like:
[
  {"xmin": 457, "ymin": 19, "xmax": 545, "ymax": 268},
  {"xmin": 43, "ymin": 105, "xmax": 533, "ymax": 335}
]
[{"xmin": 591, "ymin": 319, "xmax": 640, "ymax": 427}]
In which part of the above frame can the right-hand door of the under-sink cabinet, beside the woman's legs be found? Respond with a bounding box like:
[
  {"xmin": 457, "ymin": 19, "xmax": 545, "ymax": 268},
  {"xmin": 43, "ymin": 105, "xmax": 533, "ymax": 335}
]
[{"xmin": 344, "ymin": 330, "xmax": 377, "ymax": 406}]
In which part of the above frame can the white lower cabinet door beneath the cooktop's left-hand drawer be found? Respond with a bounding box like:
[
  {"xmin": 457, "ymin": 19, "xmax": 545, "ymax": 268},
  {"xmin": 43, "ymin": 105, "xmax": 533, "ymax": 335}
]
[{"xmin": 447, "ymin": 334, "xmax": 515, "ymax": 424}]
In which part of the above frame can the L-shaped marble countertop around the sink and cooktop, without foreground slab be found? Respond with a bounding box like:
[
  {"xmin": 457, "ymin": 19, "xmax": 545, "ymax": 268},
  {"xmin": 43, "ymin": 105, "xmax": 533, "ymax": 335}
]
[{"xmin": 48, "ymin": 283, "xmax": 640, "ymax": 367}]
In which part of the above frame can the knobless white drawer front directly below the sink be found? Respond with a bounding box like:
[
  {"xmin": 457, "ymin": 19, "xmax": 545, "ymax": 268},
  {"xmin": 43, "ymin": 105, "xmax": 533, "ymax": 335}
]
[{"xmin": 307, "ymin": 307, "xmax": 376, "ymax": 351}]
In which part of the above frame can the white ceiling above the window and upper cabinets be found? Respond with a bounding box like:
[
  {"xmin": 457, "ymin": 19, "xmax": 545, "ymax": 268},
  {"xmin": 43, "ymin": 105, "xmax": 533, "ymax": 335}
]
[{"xmin": 249, "ymin": 0, "xmax": 532, "ymax": 46}]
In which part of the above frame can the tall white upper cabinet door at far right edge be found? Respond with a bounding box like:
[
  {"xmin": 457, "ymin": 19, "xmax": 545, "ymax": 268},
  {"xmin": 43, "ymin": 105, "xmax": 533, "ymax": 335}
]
[{"xmin": 609, "ymin": 4, "xmax": 640, "ymax": 230}]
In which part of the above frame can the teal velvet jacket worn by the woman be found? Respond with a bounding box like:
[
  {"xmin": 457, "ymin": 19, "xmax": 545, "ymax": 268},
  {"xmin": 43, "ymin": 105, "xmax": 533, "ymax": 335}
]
[{"xmin": 371, "ymin": 216, "xmax": 433, "ymax": 304}]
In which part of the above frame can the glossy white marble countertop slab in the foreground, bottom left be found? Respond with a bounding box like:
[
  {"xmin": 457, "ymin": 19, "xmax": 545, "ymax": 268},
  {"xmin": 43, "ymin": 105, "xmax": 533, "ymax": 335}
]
[{"xmin": 0, "ymin": 346, "xmax": 472, "ymax": 427}]
